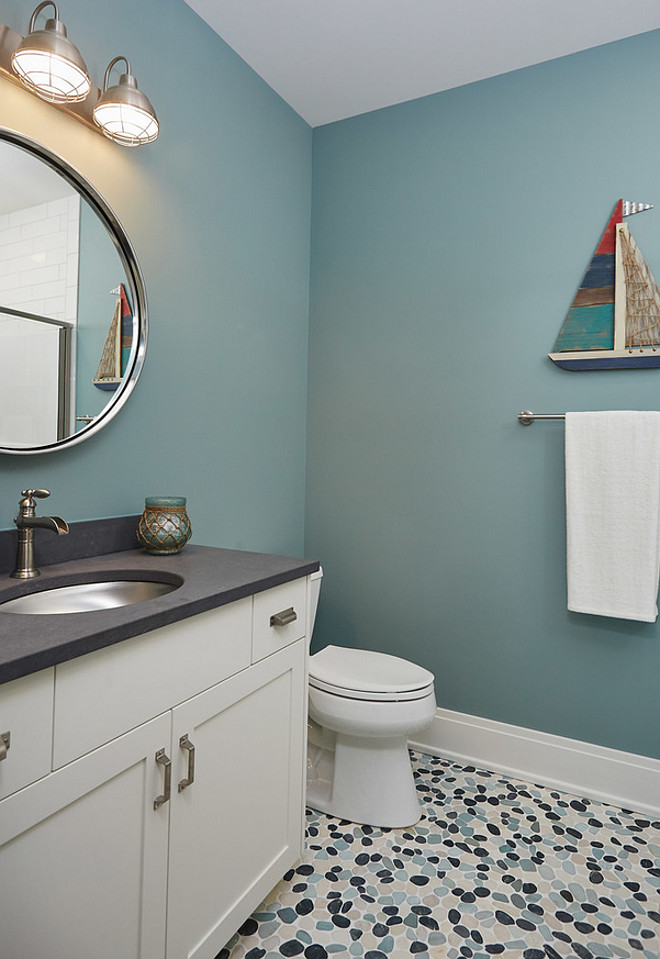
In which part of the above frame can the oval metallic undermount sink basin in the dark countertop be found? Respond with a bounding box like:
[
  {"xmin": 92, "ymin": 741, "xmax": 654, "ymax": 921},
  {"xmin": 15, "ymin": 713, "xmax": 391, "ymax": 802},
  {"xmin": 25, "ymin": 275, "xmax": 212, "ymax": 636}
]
[{"xmin": 0, "ymin": 580, "xmax": 181, "ymax": 616}]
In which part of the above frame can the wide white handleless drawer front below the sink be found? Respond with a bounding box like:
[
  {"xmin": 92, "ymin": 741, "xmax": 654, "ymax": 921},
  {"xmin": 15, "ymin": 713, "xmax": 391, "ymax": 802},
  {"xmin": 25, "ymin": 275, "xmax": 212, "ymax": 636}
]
[{"xmin": 53, "ymin": 597, "xmax": 252, "ymax": 769}]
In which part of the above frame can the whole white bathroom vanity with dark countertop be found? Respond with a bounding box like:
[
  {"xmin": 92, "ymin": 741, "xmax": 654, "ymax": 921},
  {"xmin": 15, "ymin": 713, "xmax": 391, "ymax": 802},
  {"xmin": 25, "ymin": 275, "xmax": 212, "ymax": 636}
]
[{"xmin": 0, "ymin": 528, "xmax": 318, "ymax": 959}]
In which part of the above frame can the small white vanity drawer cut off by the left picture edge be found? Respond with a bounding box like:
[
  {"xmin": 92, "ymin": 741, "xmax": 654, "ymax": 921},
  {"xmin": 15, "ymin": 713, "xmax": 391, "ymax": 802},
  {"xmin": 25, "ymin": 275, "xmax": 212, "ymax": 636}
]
[{"xmin": 0, "ymin": 669, "xmax": 54, "ymax": 799}]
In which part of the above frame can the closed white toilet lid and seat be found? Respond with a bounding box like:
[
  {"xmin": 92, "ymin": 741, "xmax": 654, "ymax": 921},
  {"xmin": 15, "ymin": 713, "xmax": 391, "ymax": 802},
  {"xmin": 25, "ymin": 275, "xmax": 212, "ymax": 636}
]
[{"xmin": 309, "ymin": 646, "xmax": 434, "ymax": 700}]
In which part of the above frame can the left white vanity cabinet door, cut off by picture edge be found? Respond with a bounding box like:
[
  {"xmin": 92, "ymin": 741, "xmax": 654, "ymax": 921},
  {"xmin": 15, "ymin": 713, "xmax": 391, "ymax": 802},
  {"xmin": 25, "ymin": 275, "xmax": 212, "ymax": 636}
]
[{"xmin": 0, "ymin": 713, "xmax": 171, "ymax": 959}]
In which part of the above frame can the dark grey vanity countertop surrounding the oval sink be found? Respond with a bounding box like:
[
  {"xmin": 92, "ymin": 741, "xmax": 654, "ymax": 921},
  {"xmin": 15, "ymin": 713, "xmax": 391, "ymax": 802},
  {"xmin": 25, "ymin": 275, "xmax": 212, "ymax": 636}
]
[{"xmin": 0, "ymin": 517, "xmax": 319, "ymax": 683}]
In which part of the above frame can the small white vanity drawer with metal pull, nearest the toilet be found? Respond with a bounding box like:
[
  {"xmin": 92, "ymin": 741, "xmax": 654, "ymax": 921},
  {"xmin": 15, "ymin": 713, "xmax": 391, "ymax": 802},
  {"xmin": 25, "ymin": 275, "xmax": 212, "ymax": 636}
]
[{"xmin": 252, "ymin": 579, "xmax": 307, "ymax": 663}]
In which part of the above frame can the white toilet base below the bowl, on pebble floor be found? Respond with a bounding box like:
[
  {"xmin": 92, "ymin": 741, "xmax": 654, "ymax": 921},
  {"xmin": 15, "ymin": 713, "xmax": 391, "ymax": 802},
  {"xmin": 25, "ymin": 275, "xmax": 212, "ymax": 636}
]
[{"xmin": 307, "ymin": 723, "xmax": 422, "ymax": 829}]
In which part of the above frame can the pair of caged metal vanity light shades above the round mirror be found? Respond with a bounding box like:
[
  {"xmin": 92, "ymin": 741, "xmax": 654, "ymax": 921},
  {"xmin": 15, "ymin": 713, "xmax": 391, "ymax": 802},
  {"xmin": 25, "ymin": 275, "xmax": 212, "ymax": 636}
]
[{"xmin": 11, "ymin": 0, "xmax": 158, "ymax": 146}]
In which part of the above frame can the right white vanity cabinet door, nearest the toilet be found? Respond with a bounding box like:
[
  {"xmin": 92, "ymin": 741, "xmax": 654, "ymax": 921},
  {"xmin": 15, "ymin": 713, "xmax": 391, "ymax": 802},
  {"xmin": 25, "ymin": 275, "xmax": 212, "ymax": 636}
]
[{"xmin": 167, "ymin": 642, "xmax": 306, "ymax": 959}]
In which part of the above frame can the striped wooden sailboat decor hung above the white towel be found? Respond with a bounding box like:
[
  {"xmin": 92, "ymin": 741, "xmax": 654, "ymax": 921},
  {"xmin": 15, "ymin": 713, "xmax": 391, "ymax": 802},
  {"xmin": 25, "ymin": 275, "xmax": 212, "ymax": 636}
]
[{"xmin": 548, "ymin": 200, "xmax": 660, "ymax": 370}]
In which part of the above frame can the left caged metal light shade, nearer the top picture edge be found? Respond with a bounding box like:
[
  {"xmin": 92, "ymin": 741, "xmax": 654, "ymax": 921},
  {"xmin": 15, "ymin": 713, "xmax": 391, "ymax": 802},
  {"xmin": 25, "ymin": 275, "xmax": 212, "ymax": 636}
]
[{"xmin": 11, "ymin": 0, "xmax": 91, "ymax": 103}]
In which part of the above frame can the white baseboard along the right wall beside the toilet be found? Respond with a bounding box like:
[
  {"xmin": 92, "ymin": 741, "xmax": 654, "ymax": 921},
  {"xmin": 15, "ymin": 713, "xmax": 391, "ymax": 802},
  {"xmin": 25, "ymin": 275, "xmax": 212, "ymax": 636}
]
[{"xmin": 409, "ymin": 709, "xmax": 660, "ymax": 818}]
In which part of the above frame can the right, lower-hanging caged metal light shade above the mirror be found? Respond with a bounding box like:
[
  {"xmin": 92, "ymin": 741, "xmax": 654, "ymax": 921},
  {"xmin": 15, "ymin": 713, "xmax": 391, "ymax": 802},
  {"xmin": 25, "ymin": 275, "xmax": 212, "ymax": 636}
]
[{"xmin": 93, "ymin": 57, "xmax": 158, "ymax": 146}]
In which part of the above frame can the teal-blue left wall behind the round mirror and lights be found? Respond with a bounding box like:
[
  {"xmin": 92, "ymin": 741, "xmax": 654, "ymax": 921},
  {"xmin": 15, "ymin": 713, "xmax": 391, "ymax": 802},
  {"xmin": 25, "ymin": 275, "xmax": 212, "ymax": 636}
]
[{"xmin": 0, "ymin": 0, "xmax": 312, "ymax": 554}]
